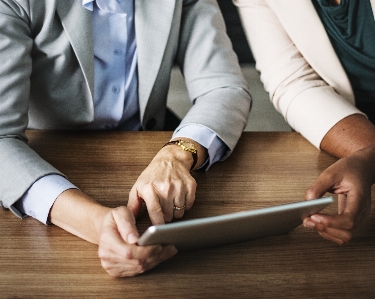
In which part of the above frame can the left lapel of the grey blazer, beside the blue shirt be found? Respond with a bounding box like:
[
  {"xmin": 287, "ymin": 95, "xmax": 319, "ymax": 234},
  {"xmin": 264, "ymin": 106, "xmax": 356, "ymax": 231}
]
[{"xmin": 56, "ymin": 0, "xmax": 94, "ymax": 99}]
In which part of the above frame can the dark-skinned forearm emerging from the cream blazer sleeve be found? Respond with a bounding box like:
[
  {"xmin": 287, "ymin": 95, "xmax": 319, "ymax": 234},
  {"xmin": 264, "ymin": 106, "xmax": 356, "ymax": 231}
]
[{"xmin": 320, "ymin": 114, "xmax": 375, "ymax": 158}]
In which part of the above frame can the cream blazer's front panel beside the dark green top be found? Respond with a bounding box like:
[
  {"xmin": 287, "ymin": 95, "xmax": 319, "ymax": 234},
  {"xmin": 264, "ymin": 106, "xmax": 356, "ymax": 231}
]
[{"xmin": 266, "ymin": 0, "xmax": 356, "ymax": 103}]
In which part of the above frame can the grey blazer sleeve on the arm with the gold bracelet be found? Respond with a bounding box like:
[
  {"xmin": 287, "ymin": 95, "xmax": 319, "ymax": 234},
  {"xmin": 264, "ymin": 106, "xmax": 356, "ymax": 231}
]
[{"xmin": 177, "ymin": 0, "xmax": 251, "ymax": 157}]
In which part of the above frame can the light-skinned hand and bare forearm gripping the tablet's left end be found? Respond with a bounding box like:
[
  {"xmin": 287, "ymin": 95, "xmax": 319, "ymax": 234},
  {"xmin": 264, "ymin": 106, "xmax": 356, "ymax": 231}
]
[{"xmin": 50, "ymin": 189, "xmax": 177, "ymax": 277}]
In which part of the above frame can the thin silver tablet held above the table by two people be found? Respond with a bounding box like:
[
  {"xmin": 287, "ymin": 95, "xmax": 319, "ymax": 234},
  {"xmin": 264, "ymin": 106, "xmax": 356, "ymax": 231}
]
[{"xmin": 138, "ymin": 197, "xmax": 333, "ymax": 251}]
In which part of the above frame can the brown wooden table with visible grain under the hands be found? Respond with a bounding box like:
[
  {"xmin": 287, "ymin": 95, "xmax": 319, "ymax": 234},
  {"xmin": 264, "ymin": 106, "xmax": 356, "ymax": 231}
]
[{"xmin": 0, "ymin": 131, "xmax": 375, "ymax": 298}]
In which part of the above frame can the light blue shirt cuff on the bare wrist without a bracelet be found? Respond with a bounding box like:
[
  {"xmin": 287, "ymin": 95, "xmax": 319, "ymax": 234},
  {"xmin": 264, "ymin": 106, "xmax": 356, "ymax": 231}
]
[{"xmin": 14, "ymin": 174, "xmax": 78, "ymax": 224}]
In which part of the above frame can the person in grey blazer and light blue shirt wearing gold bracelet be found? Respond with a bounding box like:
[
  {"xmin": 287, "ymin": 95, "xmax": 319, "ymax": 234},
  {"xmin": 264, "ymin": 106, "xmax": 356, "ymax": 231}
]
[{"xmin": 0, "ymin": 0, "xmax": 251, "ymax": 276}]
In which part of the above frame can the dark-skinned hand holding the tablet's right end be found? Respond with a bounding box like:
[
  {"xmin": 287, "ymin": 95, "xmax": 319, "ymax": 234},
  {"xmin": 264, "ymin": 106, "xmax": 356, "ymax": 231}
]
[{"xmin": 304, "ymin": 146, "xmax": 375, "ymax": 245}]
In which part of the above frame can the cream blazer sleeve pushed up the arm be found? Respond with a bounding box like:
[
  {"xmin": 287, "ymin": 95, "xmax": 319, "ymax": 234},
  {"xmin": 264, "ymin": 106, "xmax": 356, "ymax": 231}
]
[{"xmin": 233, "ymin": 0, "xmax": 361, "ymax": 148}]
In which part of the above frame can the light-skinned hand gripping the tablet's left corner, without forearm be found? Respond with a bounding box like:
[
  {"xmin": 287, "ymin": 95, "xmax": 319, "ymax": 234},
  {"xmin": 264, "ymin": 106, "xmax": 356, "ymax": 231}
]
[{"xmin": 98, "ymin": 207, "xmax": 177, "ymax": 277}]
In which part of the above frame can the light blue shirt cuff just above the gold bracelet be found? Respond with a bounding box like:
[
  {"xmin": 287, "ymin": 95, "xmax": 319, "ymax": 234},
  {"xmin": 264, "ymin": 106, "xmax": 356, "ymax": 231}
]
[{"xmin": 172, "ymin": 125, "xmax": 227, "ymax": 171}]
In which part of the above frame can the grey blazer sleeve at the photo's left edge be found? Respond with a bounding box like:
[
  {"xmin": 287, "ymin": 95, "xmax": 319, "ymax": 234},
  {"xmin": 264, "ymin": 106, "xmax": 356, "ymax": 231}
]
[{"xmin": 0, "ymin": 1, "xmax": 61, "ymax": 211}]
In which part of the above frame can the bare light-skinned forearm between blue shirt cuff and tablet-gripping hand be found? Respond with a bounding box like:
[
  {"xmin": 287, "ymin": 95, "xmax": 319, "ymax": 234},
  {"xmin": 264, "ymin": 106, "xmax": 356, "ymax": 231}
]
[{"xmin": 49, "ymin": 189, "xmax": 110, "ymax": 244}]
